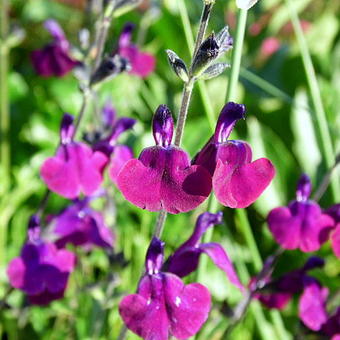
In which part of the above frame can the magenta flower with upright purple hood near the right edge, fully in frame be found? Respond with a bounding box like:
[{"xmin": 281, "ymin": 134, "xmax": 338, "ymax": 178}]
[{"xmin": 267, "ymin": 175, "xmax": 334, "ymax": 252}]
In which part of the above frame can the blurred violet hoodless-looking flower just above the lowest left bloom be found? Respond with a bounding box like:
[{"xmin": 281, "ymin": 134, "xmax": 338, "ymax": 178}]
[{"xmin": 54, "ymin": 198, "xmax": 114, "ymax": 249}]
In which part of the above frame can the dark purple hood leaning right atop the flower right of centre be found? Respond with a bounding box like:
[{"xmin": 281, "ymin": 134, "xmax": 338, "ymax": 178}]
[{"xmin": 214, "ymin": 102, "xmax": 246, "ymax": 143}]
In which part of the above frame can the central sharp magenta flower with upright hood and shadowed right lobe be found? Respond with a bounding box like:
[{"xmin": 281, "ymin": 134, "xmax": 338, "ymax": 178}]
[{"xmin": 117, "ymin": 105, "xmax": 211, "ymax": 214}]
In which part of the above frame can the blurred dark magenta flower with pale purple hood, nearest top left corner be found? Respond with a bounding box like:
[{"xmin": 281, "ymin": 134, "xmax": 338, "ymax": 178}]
[{"xmin": 31, "ymin": 20, "xmax": 80, "ymax": 77}]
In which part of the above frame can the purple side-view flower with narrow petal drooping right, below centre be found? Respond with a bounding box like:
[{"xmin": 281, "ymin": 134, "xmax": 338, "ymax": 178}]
[{"xmin": 164, "ymin": 212, "xmax": 244, "ymax": 290}]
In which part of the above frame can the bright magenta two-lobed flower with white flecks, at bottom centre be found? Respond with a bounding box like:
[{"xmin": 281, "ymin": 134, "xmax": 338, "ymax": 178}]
[{"xmin": 119, "ymin": 238, "xmax": 211, "ymax": 340}]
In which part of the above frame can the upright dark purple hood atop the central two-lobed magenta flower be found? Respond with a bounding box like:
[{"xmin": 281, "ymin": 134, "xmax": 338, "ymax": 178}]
[{"xmin": 152, "ymin": 105, "xmax": 174, "ymax": 147}]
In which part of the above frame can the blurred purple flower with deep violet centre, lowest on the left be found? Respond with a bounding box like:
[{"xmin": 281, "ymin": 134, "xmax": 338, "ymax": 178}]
[{"xmin": 7, "ymin": 216, "xmax": 76, "ymax": 305}]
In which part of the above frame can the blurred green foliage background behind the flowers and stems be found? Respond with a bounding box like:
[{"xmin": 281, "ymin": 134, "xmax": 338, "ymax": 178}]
[{"xmin": 0, "ymin": 0, "xmax": 340, "ymax": 340}]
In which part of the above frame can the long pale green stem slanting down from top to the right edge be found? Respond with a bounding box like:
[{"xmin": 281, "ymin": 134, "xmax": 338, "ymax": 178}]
[{"xmin": 285, "ymin": 0, "xmax": 340, "ymax": 201}]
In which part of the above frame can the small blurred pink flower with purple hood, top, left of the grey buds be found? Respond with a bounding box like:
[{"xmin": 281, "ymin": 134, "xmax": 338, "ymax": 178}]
[{"xmin": 118, "ymin": 23, "xmax": 156, "ymax": 78}]
